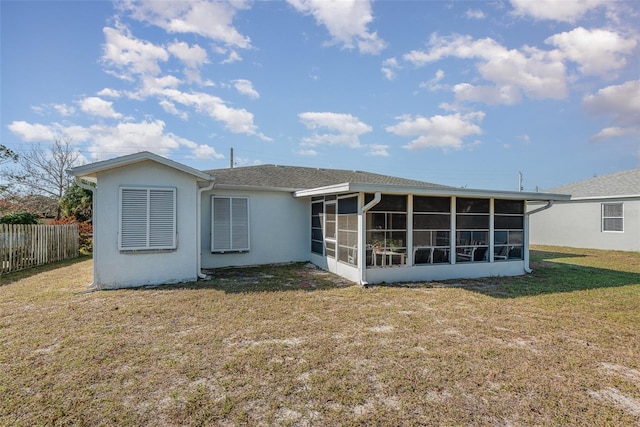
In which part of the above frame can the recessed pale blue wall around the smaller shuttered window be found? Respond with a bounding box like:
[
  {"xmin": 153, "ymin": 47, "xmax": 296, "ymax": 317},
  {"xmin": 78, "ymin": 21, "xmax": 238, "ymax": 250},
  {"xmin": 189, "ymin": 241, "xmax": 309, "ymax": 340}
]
[{"xmin": 201, "ymin": 187, "xmax": 311, "ymax": 269}]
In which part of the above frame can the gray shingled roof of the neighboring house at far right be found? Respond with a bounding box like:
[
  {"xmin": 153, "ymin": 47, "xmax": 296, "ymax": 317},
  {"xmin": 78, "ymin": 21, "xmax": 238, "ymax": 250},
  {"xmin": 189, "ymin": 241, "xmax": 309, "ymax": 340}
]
[{"xmin": 549, "ymin": 169, "xmax": 640, "ymax": 199}]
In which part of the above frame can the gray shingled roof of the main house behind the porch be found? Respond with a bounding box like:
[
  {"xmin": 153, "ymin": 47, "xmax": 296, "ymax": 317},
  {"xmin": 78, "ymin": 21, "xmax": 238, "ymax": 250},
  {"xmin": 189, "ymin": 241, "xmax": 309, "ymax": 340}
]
[{"xmin": 205, "ymin": 165, "xmax": 450, "ymax": 190}]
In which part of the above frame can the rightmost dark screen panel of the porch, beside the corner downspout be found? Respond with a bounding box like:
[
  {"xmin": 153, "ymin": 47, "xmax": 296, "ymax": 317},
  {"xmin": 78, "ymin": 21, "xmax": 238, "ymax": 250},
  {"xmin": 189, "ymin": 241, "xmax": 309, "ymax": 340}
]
[{"xmin": 493, "ymin": 199, "xmax": 524, "ymax": 261}]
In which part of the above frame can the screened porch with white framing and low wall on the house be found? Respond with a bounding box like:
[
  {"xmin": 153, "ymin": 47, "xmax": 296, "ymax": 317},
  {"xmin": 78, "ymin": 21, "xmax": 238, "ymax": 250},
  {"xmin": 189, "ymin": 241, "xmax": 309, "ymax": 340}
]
[{"xmin": 295, "ymin": 184, "xmax": 551, "ymax": 284}]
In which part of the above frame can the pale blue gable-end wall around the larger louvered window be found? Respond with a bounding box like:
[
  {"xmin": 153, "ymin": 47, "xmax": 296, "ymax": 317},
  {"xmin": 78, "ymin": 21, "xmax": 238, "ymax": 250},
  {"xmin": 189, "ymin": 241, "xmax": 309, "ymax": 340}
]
[{"xmin": 93, "ymin": 161, "xmax": 197, "ymax": 289}]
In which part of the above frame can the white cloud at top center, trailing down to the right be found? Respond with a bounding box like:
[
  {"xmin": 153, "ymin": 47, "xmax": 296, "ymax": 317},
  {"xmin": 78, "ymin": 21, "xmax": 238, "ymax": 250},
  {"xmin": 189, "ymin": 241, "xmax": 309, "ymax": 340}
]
[{"xmin": 287, "ymin": 0, "xmax": 386, "ymax": 55}]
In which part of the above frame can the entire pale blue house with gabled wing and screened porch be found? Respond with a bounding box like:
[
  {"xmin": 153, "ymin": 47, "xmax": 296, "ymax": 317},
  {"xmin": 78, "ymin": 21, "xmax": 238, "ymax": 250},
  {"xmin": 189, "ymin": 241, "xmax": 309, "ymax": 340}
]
[{"xmin": 69, "ymin": 152, "xmax": 569, "ymax": 289}]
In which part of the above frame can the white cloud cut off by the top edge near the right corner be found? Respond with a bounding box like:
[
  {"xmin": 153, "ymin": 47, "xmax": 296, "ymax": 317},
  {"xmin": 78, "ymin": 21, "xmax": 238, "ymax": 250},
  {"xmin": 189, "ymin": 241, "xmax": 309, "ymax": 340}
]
[{"xmin": 511, "ymin": 0, "xmax": 614, "ymax": 22}]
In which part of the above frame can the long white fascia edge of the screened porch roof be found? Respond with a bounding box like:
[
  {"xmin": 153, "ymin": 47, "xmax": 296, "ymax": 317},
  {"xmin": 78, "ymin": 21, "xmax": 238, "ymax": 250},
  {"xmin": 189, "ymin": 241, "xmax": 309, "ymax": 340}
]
[{"xmin": 294, "ymin": 183, "xmax": 571, "ymax": 201}]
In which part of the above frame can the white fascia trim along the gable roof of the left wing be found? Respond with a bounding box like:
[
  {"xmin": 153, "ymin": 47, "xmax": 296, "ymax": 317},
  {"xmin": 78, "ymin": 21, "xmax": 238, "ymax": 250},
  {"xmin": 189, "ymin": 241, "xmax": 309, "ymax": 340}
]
[{"xmin": 67, "ymin": 151, "xmax": 214, "ymax": 181}]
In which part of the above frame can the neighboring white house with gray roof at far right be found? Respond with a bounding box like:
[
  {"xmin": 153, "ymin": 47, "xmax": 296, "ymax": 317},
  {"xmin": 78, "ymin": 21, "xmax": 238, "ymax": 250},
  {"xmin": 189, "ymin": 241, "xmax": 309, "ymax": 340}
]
[{"xmin": 531, "ymin": 169, "xmax": 640, "ymax": 251}]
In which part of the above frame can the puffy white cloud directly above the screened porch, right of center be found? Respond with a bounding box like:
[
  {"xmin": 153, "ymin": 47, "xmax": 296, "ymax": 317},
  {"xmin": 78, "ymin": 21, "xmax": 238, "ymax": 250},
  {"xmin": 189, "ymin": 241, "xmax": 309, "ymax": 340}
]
[{"xmin": 385, "ymin": 111, "xmax": 484, "ymax": 150}]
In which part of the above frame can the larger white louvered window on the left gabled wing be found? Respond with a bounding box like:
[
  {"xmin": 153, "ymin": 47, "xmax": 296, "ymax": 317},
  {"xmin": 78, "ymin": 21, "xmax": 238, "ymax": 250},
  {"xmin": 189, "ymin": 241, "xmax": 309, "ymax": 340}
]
[{"xmin": 118, "ymin": 187, "xmax": 177, "ymax": 251}]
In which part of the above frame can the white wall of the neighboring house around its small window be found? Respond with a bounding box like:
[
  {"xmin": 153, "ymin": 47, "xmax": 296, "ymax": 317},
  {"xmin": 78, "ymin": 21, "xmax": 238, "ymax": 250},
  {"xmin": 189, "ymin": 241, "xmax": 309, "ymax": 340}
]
[{"xmin": 528, "ymin": 198, "xmax": 640, "ymax": 251}]
